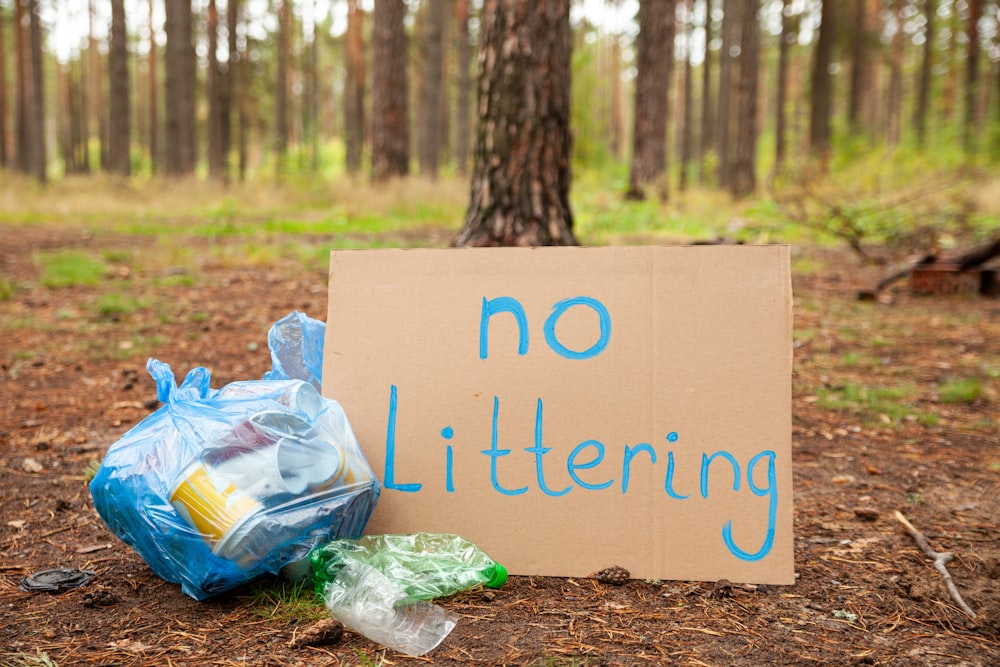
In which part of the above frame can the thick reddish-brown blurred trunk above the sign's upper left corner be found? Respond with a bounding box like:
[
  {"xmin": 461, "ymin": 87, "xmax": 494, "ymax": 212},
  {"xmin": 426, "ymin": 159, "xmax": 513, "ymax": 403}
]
[{"xmin": 372, "ymin": 0, "xmax": 410, "ymax": 181}]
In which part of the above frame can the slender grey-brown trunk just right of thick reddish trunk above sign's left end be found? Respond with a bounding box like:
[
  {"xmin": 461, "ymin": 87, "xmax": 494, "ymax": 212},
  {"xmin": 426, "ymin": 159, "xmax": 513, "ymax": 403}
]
[{"xmin": 417, "ymin": 0, "xmax": 447, "ymax": 178}]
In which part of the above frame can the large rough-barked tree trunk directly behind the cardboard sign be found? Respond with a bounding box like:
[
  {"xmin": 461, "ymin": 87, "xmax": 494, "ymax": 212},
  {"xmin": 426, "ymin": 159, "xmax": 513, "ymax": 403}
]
[{"xmin": 454, "ymin": 0, "xmax": 576, "ymax": 246}]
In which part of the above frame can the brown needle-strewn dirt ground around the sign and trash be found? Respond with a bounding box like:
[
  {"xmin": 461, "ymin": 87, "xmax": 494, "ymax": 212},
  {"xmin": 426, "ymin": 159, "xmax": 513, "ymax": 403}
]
[{"xmin": 0, "ymin": 226, "xmax": 1000, "ymax": 666}]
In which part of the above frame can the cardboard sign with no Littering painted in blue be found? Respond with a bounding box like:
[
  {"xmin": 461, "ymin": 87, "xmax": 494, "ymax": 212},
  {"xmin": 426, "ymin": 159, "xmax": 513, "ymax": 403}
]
[{"xmin": 323, "ymin": 246, "xmax": 794, "ymax": 584}]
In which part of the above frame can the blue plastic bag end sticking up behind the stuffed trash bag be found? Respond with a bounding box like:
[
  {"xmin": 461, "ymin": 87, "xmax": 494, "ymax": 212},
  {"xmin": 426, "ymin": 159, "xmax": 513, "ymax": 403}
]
[{"xmin": 264, "ymin": 310, "xmax": 326, "ymax": 392}]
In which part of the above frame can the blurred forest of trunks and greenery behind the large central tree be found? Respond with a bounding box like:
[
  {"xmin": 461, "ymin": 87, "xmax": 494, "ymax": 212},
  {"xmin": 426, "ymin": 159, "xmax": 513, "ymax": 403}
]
[{"xmin": 0, "ymin": 0, "xmax": 1000, "ymax": 252}]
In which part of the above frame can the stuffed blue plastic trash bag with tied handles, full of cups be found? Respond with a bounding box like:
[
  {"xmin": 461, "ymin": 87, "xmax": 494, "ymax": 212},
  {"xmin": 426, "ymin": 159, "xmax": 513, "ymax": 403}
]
[{"xmin": 90, "ymin": 359, "xmax": 381, "ymax": 600}]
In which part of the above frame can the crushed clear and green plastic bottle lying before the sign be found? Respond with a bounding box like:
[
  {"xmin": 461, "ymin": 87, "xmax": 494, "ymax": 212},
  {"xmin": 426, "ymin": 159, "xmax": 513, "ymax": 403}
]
[{"xmin": 309, "ymin": 533, "xmax": 507, "ymax": 655}]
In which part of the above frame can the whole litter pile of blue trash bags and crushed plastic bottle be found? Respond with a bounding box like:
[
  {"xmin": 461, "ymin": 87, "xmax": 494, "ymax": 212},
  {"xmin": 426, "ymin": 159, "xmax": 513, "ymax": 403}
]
[{"xmin": 75, "ymin": 312, "xmax": 507, "ymax": 655}]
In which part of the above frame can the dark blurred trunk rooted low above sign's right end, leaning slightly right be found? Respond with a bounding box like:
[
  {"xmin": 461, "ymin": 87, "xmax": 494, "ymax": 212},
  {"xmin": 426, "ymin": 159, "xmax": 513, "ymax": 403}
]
[{"xmin": 729, "ymin": 0, "xmax": 760, "ymax": 197}]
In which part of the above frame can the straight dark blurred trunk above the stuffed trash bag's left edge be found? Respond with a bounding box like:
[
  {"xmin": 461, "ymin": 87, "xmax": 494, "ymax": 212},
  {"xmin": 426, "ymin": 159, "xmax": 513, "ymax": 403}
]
[{"xmin": 108, "ymin": 0, "xmax": 132, "ymax": 176}]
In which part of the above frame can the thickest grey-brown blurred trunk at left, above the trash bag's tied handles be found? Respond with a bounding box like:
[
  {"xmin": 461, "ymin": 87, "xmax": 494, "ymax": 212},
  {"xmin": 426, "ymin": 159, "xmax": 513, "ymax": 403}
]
[{"xmin": 164, "ymin": 0, "xmax": 196, "ymax": 176}]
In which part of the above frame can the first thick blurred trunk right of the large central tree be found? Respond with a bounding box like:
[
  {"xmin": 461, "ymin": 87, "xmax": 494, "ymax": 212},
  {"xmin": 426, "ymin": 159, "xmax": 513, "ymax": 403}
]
[{"xmin": 628, "ymin": 0, "xmax": 677, "ymax": 201}]
